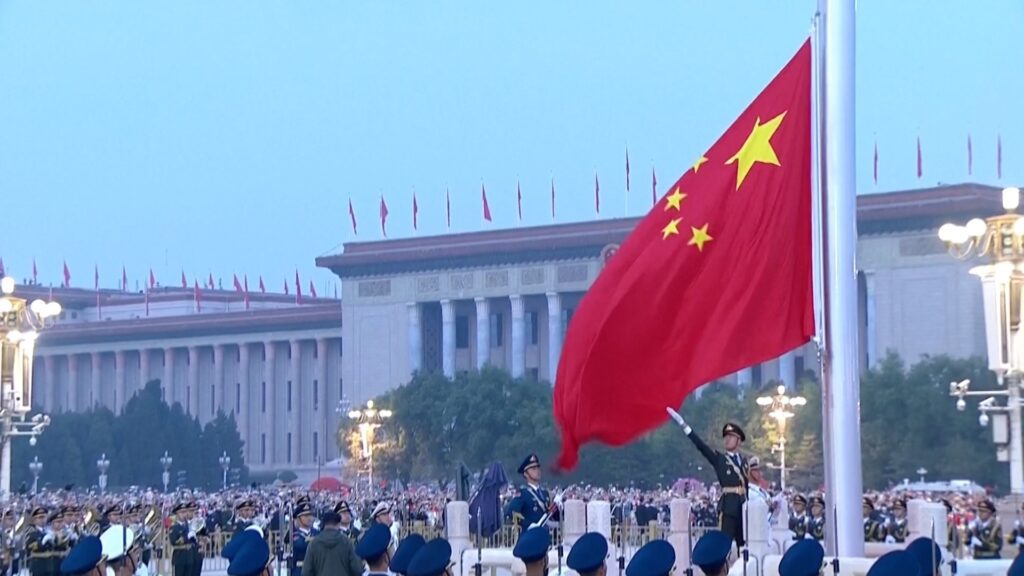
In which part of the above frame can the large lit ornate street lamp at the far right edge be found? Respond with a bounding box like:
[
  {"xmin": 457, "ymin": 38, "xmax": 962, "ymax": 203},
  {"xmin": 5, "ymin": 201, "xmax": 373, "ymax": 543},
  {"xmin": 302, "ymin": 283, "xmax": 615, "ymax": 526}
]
[{"xmin": 939, "ymin": 188, "xmax": 1024, "ymax": 494}]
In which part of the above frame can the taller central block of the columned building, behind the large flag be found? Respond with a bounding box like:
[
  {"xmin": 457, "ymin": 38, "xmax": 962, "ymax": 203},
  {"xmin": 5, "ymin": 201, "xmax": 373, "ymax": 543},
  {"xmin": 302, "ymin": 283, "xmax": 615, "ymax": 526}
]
[{"xmin": 317, "ymin": 184, "xmax": 1000, "ymax": 402}]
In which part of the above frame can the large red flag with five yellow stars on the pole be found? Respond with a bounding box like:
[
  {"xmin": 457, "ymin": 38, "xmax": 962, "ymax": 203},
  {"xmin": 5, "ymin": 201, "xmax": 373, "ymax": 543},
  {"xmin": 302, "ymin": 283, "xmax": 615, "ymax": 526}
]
[{"xmin": 554, "ymin": 41, "xmax": 814, "ymax": 469}]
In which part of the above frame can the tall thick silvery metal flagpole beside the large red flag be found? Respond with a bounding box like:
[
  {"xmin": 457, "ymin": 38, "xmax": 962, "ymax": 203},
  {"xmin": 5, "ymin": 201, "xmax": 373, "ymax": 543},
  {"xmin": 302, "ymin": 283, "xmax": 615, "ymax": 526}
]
[{"xmin": 818, "ymin": 0, "xmax": 864, "ymax": 558}]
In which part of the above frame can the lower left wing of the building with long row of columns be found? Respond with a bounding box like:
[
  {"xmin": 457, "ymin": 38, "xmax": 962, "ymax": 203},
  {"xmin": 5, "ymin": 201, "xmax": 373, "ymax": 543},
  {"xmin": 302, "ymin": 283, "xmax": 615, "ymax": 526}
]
[{"xmin": 18, "ymin": 286, "xmax": 343, "ymax": 471}]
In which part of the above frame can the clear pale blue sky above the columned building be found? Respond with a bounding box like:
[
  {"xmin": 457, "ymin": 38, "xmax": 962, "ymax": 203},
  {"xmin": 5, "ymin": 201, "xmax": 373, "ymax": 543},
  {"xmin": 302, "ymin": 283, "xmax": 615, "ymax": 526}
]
[{"xmin": 0, "ymin": 0, "xmax": 1024, "ymax": 290}]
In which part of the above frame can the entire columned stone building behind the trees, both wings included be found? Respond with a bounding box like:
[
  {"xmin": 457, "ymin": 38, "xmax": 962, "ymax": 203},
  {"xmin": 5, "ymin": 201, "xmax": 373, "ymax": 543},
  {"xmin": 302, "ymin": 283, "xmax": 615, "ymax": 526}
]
[{"xmin": 18, "ymin": 183, "xmax": 1000, "ymax": 471}]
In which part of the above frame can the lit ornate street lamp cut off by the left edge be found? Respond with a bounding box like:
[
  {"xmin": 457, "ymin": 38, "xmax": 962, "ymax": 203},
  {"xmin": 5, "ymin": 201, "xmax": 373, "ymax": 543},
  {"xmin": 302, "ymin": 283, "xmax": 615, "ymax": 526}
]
[{"xmin": 0, "ymin": 277, "xmax": 61, "ymax": 501}]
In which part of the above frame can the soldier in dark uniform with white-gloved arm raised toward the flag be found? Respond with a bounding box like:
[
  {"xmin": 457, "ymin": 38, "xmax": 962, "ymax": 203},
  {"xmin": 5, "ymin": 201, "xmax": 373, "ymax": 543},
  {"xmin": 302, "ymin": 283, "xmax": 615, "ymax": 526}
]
[{"xmin": 667, "ymin": 408, "xmax": 748, "ymax": 548}]
